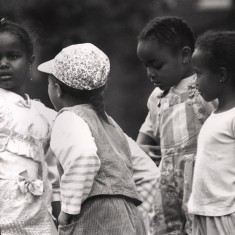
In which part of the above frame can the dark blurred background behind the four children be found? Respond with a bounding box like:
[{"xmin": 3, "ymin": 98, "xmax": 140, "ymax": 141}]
[{"xmin": 0, "ymin": 0, "xmax": 235, "ymax": 139}]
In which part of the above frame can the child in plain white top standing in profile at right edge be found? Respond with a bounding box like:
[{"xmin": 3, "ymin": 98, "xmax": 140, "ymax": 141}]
[{"xmin": 188, "ymin": 31, "xmax": 235, "ymax": 235}]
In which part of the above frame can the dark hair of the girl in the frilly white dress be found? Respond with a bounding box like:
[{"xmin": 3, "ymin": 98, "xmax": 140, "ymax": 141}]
[{"xmin": 0, "ymin": 18, "xmax": 34, "ymax": 58}]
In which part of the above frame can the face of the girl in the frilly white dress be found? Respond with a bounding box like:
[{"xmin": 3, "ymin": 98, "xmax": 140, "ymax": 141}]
[{"xmin": 0, "ymin": 32, "xmax": 30, "ymax": 95}]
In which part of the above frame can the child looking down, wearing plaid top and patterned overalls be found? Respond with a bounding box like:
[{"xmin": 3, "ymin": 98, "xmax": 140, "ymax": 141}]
[{"xmin": 137, "ymin": 17, "xmax": 217, "ymax": 235}]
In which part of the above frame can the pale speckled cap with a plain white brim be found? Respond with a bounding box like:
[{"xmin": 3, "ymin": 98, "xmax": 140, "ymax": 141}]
[{"xmin": 38, "ymin": 43, "xmax": 110, "ymax": 90}]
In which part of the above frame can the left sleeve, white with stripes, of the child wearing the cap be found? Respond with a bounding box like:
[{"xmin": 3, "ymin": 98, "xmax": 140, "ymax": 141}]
[{"xmin": 51, "ymin": 111, "xmax": 100, "ymax": 214}]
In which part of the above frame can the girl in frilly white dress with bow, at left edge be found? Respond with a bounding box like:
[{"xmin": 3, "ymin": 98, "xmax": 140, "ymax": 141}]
[{"xmin": 0, "ymin": 19, "xmax": 57, "ymax": 235}]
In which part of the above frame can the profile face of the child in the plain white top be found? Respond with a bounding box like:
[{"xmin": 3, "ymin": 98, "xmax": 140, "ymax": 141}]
[{"xmin": 192, "ymin": 49, "xmax": 220, "ymax": 101}]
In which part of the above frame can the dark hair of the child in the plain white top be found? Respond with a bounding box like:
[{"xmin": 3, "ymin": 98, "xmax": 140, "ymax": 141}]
[{"xmin": 196, "ymin": 31, "xmax": 235, "ymax": 75}]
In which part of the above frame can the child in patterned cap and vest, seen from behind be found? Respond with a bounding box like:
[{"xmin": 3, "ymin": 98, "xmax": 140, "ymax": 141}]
[{"xmin": 38, "ymin": 43, "xmax": 150, "ymax": 235}]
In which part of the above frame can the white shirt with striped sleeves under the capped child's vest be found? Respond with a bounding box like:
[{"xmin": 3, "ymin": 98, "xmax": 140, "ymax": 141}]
[{"xmin": 51, "ymin": 111, "xmax": 159, "ymax": 216}]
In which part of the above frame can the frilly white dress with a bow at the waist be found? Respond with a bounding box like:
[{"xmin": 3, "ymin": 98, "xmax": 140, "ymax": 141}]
[{"xmin": 0, "ymin": 89, "xmax": 57, "ymax": 235}]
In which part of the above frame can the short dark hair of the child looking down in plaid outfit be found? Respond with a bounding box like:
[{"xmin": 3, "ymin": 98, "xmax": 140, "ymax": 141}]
[{"xmin": 137, "ymin": 16, "xmax": 195, "ymax": 53}]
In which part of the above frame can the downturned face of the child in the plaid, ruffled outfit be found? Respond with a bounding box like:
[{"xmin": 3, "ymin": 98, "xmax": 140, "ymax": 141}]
[{"xmin": 137, "ymin": 39, "xmax": 184, "ymax": 90}]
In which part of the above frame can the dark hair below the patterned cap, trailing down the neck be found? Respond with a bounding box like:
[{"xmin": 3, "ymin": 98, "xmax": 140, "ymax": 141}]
[{"xmin": 54, "ymin": 77, "xmax": 110, "ymax": 124}]
